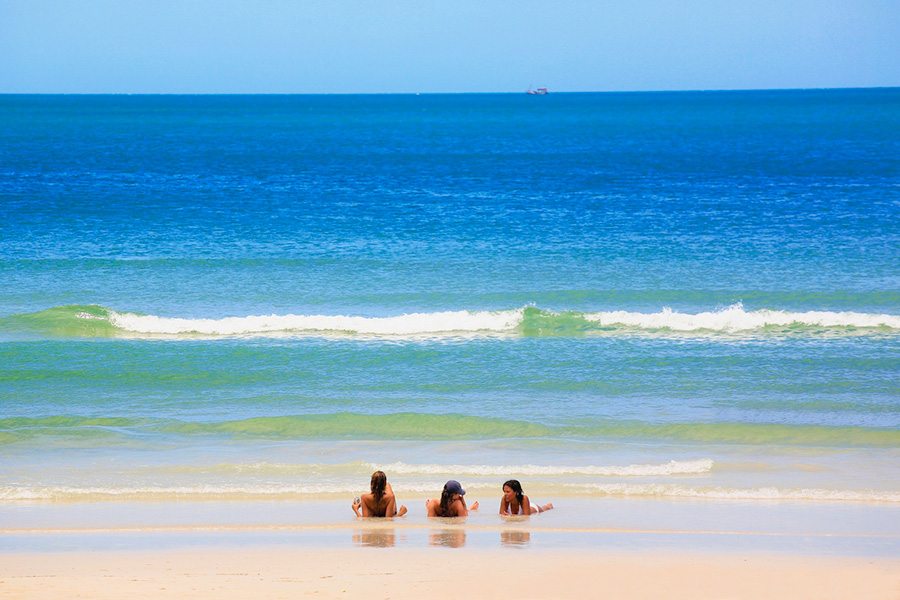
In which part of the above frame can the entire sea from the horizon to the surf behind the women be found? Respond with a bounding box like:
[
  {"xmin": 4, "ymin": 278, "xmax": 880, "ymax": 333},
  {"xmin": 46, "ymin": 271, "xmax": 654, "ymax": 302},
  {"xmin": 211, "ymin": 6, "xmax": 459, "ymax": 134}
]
[{"xmin": 0, "ymin": 89, "xmax": 900, "ymax": 506}]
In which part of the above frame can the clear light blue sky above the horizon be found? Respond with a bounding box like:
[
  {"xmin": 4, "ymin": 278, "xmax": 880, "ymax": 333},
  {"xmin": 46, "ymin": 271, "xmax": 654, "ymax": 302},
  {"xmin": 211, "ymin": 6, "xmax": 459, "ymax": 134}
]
[{"xmin": 0, "ymin": 0, "xmax": 900, "ymax": 94}]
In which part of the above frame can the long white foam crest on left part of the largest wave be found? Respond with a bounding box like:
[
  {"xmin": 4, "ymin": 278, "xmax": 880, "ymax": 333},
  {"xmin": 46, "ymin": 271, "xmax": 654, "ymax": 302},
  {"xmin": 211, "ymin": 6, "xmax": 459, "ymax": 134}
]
[{"xmin": 109, "ymin": 309, "xmax": 523, "ymax": 335}]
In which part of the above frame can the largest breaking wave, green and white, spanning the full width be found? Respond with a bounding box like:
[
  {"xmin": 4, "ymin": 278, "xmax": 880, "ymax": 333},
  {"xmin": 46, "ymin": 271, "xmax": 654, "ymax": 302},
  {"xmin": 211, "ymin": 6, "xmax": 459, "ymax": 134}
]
[{"xmin": 0, "ymin": 304, "xmax": 900, "ymax": 339}]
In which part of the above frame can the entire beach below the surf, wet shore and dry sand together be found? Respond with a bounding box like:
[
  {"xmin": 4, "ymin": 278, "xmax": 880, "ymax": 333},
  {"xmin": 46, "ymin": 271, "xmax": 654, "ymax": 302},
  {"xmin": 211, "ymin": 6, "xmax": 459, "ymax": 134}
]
[{"xmin": 0, "ymin": 498, "xmax": 900, "ymax": 600}]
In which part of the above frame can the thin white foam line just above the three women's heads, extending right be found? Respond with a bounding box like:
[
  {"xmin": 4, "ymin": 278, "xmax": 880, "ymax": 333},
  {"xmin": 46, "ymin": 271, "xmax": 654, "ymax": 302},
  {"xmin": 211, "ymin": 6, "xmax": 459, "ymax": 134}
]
[{"xmin": 369, "ymin": 458, "xmax": 713, "ymax": 477}]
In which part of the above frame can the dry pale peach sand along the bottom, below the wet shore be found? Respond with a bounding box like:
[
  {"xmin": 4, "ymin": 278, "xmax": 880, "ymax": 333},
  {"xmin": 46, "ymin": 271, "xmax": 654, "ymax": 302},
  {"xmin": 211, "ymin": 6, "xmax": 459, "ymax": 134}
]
[{"xmin": 0, "ymin": 548, "xmax": 900, "ymax": 600}]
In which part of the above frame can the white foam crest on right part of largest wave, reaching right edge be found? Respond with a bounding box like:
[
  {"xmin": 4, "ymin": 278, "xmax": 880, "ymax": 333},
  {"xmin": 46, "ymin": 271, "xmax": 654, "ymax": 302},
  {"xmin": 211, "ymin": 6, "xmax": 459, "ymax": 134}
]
[{"xmin": 585, "ymin": 304, "xmax": 900, "ymax": 332}]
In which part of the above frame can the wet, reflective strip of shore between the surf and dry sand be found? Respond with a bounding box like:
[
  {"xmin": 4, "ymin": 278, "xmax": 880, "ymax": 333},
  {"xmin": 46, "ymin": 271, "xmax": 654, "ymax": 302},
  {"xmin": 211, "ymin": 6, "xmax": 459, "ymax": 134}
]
[{"xmin": 0, "ymin": 492, "xmax": 900, "ymax": 556}]
